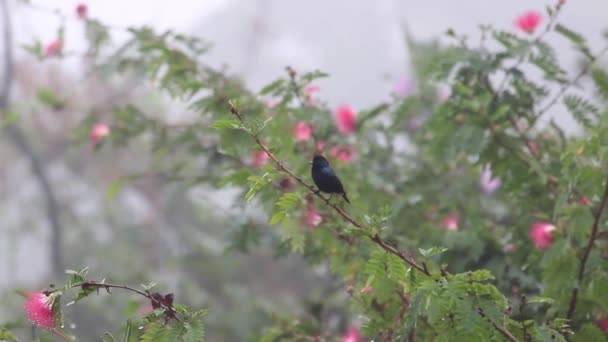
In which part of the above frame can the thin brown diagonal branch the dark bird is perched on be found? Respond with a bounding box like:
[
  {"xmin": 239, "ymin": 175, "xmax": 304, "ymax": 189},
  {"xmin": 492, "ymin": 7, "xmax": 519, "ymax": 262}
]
[{"xmin": 228, "ymin": 101, "xmax": 431, "ymax": 276}]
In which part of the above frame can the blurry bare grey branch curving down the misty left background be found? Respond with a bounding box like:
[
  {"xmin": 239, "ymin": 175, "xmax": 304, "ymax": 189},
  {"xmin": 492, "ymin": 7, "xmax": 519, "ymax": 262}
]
[{"xmin": 0, "ymin": 0, "xmax": 64, "ymax": 274}]
